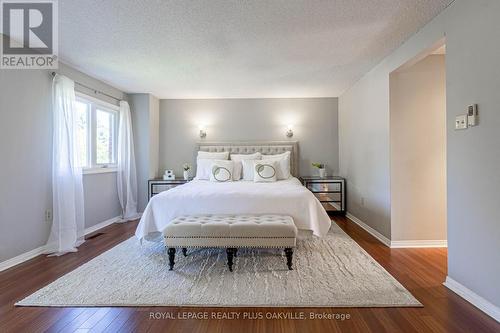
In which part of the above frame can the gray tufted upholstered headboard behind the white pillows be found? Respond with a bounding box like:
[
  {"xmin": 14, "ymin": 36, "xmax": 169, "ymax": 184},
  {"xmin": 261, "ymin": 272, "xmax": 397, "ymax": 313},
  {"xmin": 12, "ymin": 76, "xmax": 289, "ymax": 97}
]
[{"xmin": 196, "ymin": 141, "xmax": 299, "ymax": 177}]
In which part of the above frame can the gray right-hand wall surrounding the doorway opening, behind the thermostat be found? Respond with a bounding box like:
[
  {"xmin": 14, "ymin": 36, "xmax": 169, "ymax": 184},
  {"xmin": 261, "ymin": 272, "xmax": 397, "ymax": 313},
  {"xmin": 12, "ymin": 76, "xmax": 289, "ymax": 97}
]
[{"xmin": 339, "ymin": 0, "xmax": 500, "ymax": 306}]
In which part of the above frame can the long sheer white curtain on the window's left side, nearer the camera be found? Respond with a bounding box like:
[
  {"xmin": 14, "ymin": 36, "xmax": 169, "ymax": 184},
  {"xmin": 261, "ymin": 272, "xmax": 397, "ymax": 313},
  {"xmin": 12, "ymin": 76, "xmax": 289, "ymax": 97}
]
[{"xmin": 47, "ymin": 74, "xmax": 85, "ymax": 255}]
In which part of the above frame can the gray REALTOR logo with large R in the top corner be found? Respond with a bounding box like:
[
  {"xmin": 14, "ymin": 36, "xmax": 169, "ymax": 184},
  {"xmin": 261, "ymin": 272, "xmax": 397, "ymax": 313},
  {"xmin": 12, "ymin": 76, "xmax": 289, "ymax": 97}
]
[{"xmin": 0, "ymin": 0, "xmax": 57, "ymax": 69}]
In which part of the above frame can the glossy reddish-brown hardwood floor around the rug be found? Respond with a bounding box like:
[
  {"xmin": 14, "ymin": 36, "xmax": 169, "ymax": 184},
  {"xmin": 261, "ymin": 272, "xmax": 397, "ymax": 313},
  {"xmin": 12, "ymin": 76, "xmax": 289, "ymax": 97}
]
[{"xmin": 0, "ymin": 217, "xmax": 500, "ymax": 333}]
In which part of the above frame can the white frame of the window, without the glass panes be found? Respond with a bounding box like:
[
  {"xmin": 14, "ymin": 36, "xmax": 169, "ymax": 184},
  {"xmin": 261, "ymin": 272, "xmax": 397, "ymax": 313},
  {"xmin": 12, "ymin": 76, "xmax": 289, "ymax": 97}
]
[{"xmin": 75, "ymin": 92, "xmax": 120, "ymax": 174}]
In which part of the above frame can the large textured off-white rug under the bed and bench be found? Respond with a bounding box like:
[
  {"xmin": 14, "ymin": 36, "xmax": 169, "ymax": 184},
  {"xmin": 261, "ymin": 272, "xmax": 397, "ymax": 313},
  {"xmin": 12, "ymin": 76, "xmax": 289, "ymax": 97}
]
[{"xmin": 17, "ymin": 223, "xmax": 421, "ymax": 307}]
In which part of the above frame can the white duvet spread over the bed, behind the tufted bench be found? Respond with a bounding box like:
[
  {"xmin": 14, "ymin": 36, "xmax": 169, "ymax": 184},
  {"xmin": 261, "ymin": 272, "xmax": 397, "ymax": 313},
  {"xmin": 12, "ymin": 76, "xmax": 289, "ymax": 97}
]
[{"xmin": 135, "ymin": 178, "xmax": 331, "ymax": 240}]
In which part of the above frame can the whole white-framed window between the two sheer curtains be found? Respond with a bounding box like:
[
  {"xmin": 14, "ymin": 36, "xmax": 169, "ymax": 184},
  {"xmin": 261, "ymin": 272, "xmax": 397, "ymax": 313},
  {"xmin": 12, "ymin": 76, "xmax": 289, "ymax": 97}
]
[{"xmin": 76, "ymin": 95, "xmax": 118, "ymax": 169}]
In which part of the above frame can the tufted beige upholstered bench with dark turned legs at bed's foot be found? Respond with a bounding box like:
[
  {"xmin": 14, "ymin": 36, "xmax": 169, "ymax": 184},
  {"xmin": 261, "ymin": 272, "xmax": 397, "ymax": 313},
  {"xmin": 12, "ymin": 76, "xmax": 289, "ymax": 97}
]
[{"xmin": 163, "ymin": 215, "xmax": 297, "ymax": 272}]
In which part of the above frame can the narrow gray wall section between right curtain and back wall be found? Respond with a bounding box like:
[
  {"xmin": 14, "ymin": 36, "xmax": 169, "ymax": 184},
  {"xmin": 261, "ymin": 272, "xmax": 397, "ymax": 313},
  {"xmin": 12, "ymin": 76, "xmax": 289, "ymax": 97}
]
[{"xmin": 128, "ymin": 94, "xmax": 159, "ymax": 212}]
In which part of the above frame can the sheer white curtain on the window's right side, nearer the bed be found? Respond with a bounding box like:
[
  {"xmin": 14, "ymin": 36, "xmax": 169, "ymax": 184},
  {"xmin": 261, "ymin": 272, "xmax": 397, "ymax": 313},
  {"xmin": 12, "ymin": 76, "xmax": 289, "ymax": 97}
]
[{"xmin": 116, "ymin": 101, "xmax": 139, "ymax": 222}]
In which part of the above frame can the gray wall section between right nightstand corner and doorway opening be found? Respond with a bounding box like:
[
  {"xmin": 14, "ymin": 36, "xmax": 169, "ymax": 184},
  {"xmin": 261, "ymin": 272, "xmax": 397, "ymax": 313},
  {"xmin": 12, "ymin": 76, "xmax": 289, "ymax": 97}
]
[{"xmin": 339, "ymin": 71, "xmax": 391, "ymax": 239}]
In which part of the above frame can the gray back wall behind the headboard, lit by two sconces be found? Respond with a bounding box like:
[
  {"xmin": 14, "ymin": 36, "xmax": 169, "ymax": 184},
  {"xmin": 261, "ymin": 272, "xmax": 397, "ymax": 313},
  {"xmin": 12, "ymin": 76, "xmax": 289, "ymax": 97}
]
[{"xmin": 160, "ymin": 98, "xmax": 338, "ymax": 177}]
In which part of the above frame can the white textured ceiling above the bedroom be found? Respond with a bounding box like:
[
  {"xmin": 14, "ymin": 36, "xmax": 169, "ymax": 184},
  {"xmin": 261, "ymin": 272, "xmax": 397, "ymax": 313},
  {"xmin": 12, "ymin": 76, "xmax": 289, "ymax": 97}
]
[{"xmin": 59, "ymin": 0, "xmax": 452, "ymax": 98}]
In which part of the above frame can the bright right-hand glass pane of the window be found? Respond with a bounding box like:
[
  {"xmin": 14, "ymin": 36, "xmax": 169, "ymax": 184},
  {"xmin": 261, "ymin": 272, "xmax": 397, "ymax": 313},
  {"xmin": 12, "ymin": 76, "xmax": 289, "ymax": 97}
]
[{"xmin": 96, "ymin": 109, "xmax": 116, "ymax": 164}]
